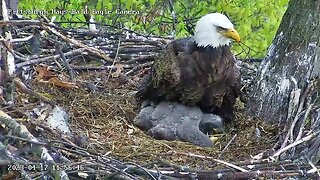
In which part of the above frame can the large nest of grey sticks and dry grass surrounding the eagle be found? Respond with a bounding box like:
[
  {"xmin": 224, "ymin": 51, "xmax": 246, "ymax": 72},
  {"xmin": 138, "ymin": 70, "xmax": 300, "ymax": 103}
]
[{"xmin": 0, "ymin": 16, "xmax": 317, "ymax": 179}]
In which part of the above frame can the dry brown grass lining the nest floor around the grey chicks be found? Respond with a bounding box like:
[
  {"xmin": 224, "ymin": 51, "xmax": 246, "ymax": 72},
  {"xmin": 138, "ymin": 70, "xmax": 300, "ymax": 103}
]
[{"xmin": 16, "ymin": 72, "xmax": 278, "ymax": 169}]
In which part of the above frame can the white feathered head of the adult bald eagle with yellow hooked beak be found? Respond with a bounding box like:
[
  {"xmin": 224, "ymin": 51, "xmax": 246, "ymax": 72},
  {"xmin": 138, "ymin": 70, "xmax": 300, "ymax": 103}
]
[{"xmin": 194, "ymin": 13, "xmax": 240, "ymax": 48}]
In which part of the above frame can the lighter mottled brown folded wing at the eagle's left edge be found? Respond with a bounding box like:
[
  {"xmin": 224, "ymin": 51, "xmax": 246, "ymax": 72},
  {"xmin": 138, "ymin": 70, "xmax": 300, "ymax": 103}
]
[{"xmin": 135, "ymin": 43, "xmax": 180, "ymax": 100}]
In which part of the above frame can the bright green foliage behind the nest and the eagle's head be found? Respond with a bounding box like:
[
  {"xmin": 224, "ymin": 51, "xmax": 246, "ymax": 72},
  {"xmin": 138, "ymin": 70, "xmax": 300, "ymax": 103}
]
[{"xmin": 19, "ymin": 0, "xmax": 288, "ymax": 58}]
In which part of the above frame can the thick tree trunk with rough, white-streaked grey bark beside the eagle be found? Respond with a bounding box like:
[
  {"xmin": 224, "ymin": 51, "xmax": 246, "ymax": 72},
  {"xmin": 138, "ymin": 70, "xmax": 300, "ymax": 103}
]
[{"xmin": 246, "ymin": 0, "xmax": 320, "ymax": 122}]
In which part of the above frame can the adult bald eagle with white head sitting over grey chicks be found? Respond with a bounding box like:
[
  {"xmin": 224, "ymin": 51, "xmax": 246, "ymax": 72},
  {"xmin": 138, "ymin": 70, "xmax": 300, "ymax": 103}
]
[{"xmin": 135, "ymin": 13, "xmax": 240, "ymax": 120}]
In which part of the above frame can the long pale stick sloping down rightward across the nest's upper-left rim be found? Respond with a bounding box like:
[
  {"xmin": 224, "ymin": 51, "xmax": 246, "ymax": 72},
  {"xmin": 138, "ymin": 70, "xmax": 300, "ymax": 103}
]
[{"xmin": 42, "ymin": 25, "xmax": 112, "ymax": 62}]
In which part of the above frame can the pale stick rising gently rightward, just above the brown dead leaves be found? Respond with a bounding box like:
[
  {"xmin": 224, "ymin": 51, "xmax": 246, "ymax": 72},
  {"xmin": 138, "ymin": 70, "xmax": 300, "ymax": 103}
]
[{"xmin": 17, "ymin": 48, "xmax": 86, "ymax": 68}]
